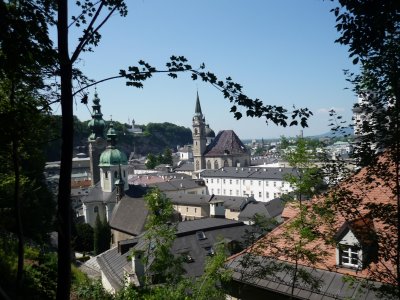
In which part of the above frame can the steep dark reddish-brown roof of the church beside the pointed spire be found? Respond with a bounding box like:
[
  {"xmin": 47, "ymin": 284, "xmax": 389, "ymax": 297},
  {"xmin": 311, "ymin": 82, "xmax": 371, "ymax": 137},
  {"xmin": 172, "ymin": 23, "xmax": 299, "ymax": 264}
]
[{"xmin": 204, "ymin": 130, "xmax": 248, "ymax": 156}]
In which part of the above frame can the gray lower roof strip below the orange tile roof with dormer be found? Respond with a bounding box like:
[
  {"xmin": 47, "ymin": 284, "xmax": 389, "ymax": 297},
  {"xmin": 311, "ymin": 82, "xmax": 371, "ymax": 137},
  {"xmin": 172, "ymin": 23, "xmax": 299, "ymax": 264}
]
[{"xmin": 226, "ymin": 254, "xmax": 379, "ymax": 300}]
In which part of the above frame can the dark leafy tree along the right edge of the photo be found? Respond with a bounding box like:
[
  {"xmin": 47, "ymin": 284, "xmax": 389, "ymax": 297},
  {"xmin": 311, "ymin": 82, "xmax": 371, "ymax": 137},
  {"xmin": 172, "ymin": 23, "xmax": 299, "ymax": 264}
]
[{"xmin": 333, "ymin": 0, "xmax": 400, "ymax": 297}]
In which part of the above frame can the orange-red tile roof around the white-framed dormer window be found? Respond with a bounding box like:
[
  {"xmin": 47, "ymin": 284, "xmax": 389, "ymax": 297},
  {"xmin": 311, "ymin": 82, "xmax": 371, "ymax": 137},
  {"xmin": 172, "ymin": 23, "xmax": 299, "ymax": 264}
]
[{"xmin": 233, "ymin": 157, "xmax": 398, "ymax": 284}]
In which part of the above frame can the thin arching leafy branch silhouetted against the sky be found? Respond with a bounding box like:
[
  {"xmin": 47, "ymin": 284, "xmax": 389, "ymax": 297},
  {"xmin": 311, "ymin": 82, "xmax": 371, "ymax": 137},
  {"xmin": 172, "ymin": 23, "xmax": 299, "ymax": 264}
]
[{"xmin": 119, "ymin": 55, "xmax": 312, "ymax": 127}]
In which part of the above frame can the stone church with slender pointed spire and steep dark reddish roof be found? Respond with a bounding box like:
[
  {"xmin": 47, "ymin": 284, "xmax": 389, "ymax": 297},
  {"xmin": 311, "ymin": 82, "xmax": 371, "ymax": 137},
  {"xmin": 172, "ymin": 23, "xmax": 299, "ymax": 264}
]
[{"xmin": 192, "ymin": 93, "xmax": 250, "ymax": 171}]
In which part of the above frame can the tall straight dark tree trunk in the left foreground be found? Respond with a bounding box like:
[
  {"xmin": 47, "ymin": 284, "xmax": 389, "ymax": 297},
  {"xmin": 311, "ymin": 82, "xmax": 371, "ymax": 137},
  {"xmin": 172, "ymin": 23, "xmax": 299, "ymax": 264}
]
[{"xmin": 57, "ymin": 0, "xmax": 74, "ymax": 300}]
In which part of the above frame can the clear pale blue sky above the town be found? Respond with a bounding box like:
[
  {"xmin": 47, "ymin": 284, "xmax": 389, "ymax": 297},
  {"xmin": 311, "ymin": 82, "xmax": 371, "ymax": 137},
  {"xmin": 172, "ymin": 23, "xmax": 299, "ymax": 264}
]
[{"xmin": 58, "ymin": 0, "xmax": 356, "ymax": 139}]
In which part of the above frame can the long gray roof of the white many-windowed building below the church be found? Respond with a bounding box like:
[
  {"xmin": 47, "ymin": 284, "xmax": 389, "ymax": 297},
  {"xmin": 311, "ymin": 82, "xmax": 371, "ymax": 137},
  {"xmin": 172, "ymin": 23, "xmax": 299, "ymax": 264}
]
[{"xmin": 200, "ymin": 167, "xmax": 295, "ymax": 180}]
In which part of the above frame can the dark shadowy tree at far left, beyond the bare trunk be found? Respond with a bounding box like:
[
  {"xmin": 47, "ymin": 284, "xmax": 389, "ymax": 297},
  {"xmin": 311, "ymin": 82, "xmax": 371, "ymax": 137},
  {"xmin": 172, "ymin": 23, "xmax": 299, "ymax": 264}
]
[{"xmin": 0, "ymin": 1, "xmax": 55, "ymax": 297}]
